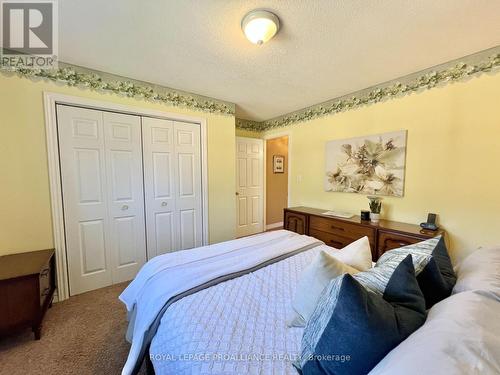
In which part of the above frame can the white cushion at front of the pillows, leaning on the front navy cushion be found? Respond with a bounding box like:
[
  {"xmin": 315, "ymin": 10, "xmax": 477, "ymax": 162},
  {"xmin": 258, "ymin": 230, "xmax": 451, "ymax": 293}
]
[{"xmin": 288, "ymin": 250, "xmax": 359, "ymax": 327}]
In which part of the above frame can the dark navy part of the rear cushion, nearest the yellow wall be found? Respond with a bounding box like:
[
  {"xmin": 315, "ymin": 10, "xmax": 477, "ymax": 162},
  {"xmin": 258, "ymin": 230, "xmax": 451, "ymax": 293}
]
[{"xmin": 417, "ymin": 237, "xmax": 457, "ymax": 309}]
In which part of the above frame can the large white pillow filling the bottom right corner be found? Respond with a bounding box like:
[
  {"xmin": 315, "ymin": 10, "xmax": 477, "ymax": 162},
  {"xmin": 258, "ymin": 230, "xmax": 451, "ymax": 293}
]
[{"xmin": 370, "ymin": 291, "xmax": 500, "ymax": 375}]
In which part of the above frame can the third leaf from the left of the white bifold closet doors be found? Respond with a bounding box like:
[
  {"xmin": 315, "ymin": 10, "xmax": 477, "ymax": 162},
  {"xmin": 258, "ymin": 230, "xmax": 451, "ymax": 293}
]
[{"xmin": 142, "ymin": 117, "xmax": 179, "ymax": 259}]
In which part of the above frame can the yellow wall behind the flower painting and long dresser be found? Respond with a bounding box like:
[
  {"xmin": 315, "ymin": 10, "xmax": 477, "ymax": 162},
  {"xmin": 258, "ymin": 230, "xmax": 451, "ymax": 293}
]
[{"xmin": 266, "ymin": 74, "xmax": 500, "ymax": 259}]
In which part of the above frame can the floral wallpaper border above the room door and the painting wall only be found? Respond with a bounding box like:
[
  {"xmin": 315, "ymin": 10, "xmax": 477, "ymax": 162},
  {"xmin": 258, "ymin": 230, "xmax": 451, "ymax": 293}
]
[{"xmin": 237, "ymin": 53, "xmax": 500, "ymax": 132}]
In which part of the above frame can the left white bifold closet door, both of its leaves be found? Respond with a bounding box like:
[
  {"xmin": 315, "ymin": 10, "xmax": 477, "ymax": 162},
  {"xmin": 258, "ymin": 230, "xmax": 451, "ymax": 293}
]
[{"xmin": 57, "ymin": 105, "xmax": 146, "ymax": 295}]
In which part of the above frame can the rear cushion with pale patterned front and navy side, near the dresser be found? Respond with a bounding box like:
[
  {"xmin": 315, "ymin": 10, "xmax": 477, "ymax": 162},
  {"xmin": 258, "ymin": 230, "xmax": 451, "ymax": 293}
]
[{"xmin": 375, "ymin": 236, "xmax": 457, "ymax": 309}]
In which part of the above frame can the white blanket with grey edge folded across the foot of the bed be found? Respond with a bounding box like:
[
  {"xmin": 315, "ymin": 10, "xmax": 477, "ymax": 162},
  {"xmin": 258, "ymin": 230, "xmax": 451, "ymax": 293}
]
[{"xmin": 119, "ymin": 230, "xmax": 322, "ymax": 375}]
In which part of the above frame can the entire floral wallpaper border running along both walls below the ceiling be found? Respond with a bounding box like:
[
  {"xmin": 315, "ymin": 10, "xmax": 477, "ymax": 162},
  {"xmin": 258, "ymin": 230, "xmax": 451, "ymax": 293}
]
[{"xmin": 0, "ymin": 48, "xmax": 500, "ymax": 132}]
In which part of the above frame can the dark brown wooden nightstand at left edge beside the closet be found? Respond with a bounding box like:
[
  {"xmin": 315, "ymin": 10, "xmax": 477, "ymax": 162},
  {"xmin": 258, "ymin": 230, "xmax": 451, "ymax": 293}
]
[{"xmin": 0, "ymin": 249, "xmax": 55, "ymax": 340}]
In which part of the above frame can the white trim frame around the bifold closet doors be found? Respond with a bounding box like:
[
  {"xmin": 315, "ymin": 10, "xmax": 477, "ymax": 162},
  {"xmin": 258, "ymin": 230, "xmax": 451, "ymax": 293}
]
[{"xmin": 43, "ymin": 91, "xmax": 209, "ymax": 301}]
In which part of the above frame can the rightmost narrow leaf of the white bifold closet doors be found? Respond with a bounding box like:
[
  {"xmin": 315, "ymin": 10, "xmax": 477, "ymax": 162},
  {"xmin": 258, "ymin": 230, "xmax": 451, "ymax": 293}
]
[{"xmin": 174, "ymin": 121, "xmax": 203, "ymax": 249}]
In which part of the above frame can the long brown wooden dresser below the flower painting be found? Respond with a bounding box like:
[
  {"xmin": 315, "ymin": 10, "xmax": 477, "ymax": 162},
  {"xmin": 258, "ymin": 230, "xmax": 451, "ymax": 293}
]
[{"xmin": 283, "ymin": 207, "xmax": 443, "ymax": 261}]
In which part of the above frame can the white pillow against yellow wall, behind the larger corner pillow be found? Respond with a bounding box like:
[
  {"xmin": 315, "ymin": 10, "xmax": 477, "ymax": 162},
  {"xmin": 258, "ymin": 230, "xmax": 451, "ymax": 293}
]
[{"xmin": 453, "ymin": 247, "xmax": 500, "ymax": 300}]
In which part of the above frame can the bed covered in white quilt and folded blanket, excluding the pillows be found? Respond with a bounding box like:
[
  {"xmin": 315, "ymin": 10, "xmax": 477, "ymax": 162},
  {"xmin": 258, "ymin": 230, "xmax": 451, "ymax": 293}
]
[{"xmin": 120, "ymin": 230, "xmax": 500, "ymax": 374}]
